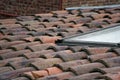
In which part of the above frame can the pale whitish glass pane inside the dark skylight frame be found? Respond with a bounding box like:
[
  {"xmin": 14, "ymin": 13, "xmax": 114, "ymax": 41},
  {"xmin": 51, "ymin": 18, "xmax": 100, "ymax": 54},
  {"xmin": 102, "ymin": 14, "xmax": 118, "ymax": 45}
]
[{"xmin": 65, "ymin": 26, "xmax": 120, "ymax": 43}]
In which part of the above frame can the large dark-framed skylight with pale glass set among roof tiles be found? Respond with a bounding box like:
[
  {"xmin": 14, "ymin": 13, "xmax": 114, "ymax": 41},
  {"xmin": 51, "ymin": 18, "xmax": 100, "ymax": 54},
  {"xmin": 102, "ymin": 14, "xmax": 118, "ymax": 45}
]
[{"xmin": 56, "ymin": 24, "xmax": 120, "ymax": 47}]
